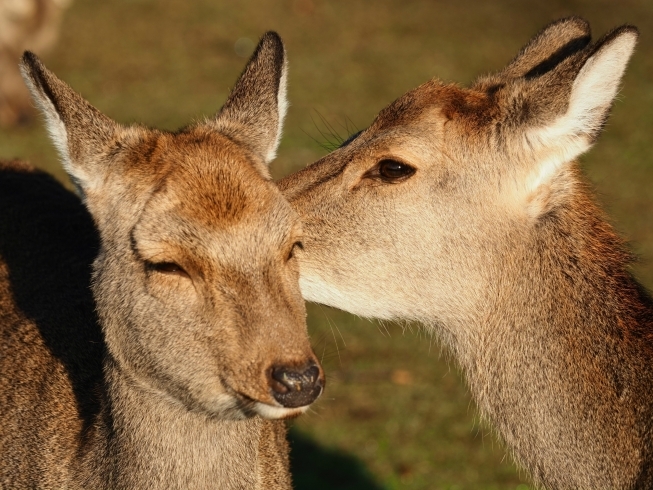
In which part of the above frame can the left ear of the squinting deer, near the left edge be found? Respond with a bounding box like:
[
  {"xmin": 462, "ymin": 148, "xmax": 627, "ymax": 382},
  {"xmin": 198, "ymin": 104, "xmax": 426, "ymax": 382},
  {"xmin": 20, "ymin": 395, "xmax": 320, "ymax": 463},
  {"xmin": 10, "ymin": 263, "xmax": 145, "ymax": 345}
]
[{"xmin": 20, "ymin": 51, "xmax": 119, "ymax": 194}]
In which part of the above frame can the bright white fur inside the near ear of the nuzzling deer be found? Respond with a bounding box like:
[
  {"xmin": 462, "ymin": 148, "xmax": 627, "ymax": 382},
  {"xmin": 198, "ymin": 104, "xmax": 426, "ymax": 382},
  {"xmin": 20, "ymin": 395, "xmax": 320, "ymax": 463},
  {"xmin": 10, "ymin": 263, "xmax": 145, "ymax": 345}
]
[{"xmin": 525, "ymin": 28, "xmax": 637, "ymax": 190}]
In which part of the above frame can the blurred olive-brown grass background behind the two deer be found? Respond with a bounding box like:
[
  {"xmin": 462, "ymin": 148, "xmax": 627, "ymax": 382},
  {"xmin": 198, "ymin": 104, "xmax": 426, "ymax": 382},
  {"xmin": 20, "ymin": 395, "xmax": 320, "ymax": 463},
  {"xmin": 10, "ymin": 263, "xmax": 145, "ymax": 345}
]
[{"xmin": 0, "ymin": 0, "xmax": 653, "ymax": 490}]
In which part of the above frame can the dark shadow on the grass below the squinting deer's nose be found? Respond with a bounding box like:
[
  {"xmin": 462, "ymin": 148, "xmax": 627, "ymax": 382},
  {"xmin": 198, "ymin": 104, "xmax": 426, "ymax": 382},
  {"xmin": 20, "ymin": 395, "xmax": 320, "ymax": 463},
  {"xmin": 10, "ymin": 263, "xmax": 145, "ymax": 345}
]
[{"xmin": 288, "ymin": 428, "xmax": 384, "ymax": 490}]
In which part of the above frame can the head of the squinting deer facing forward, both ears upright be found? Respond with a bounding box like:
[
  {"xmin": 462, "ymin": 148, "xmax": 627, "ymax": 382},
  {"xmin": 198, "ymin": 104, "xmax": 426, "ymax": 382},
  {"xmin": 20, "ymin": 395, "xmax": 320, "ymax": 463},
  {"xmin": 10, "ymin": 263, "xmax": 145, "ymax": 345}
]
[{"xmin": 22, "ymin": 33, "xmax": 324, "ymax": 418}]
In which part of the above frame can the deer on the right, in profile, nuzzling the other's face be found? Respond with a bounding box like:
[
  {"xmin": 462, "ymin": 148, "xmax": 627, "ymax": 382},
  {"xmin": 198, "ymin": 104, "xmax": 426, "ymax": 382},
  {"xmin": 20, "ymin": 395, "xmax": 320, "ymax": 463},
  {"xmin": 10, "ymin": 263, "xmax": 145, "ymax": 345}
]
[{"xmin": 279, "ymin": 17, "xmax": 653, "ymax": 489}]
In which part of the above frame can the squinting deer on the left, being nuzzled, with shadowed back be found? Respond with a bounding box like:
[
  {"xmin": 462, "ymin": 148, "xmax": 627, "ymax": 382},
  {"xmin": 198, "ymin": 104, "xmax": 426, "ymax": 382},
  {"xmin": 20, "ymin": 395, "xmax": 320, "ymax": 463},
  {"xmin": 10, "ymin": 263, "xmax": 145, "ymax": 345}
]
[{"xmin": 0, "ymin": 32, "xmax": 324, "ymax": 490}]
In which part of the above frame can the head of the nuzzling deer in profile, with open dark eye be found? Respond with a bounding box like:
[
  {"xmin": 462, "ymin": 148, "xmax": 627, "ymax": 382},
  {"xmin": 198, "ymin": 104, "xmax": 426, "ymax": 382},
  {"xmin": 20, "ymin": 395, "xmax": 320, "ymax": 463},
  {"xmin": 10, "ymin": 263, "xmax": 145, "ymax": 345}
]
[{"xmin": 279, "ymin": 18, "xmax": 637, "ymax": 329}]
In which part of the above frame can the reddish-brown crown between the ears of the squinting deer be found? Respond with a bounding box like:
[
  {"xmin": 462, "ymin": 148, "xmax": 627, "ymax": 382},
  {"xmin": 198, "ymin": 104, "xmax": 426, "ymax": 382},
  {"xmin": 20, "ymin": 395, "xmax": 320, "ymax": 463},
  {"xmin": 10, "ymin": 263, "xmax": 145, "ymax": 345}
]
[{"xmin": 114, "ymin": 128, "xmax": 289, "ymax": 223}]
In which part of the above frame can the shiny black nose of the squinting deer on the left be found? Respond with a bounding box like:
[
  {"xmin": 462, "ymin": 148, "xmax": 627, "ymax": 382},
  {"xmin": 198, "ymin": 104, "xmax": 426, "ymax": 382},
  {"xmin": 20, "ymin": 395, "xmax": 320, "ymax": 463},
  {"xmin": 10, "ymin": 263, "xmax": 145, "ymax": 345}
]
[{"xmin": 270, "ymin": 364, "xmax": 324, "ymax": 408}]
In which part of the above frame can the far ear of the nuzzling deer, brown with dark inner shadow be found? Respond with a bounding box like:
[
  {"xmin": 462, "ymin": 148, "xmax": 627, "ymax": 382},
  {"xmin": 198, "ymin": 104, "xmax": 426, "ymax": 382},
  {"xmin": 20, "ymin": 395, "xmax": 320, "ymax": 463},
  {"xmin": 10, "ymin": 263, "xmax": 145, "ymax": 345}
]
[{"xmin": 499, "ymin": 17, "xmax": 592, "ymax": 78}]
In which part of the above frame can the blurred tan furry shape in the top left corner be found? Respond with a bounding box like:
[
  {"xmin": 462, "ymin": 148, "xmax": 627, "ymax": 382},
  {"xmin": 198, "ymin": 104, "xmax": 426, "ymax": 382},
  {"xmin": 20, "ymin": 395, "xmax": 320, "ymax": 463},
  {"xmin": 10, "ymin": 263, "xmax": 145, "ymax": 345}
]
[{"xmin": 0, "ymin": 0, "xmax": 71, "ymax": 127}]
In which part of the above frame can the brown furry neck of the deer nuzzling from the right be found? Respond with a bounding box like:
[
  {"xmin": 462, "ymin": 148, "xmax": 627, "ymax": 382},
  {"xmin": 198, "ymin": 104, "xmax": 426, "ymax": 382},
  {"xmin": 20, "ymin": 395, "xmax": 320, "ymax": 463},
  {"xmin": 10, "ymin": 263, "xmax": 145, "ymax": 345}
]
[{"xmin": 444, "ymin": 188, "xmax": 653, "ymax": 488}]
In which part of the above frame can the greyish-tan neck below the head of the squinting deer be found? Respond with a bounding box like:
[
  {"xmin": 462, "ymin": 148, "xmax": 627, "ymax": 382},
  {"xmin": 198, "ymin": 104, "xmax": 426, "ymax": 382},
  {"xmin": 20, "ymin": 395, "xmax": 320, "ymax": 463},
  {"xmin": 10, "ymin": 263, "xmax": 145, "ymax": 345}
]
[{"xmin": 80, "ymin": 357, "xmax": 265, "ymax": 489}]
